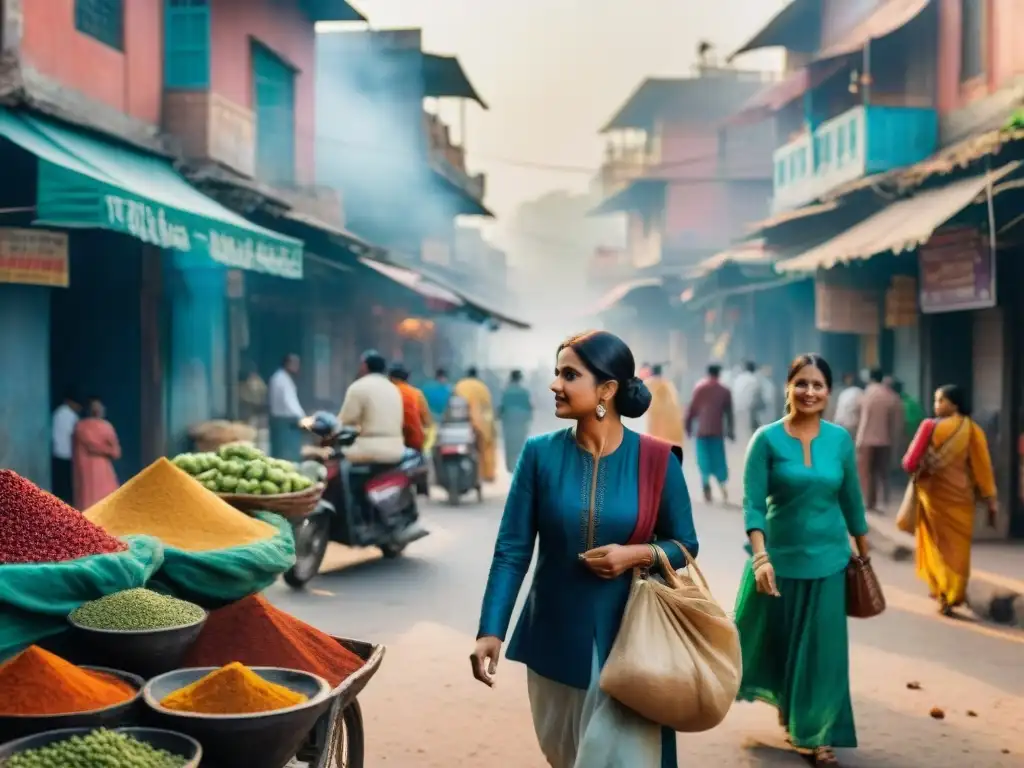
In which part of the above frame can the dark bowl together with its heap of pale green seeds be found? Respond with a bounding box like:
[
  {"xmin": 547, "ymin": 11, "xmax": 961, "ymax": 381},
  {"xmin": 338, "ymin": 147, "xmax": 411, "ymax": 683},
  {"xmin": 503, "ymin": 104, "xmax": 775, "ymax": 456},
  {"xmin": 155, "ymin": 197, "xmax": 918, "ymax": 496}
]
[{"xmin": 68, "ymin": 588, "xmax": 207, "ymax": 678}]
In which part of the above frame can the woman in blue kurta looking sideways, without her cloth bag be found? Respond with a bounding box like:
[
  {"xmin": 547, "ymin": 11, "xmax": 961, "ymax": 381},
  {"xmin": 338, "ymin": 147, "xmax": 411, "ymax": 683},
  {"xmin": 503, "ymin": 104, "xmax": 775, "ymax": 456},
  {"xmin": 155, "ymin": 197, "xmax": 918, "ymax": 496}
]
[{"xmin": 471, "ymin": 332, "xmax": 697, "ymax": 768}]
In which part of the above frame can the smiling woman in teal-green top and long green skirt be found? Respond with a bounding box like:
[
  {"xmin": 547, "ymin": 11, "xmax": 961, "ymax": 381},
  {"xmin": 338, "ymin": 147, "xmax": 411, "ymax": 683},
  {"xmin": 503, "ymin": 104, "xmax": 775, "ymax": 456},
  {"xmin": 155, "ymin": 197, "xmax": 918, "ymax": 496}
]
[{"xmin": 736, "ymin": 354, "xmax": 867, "ymax": 766}]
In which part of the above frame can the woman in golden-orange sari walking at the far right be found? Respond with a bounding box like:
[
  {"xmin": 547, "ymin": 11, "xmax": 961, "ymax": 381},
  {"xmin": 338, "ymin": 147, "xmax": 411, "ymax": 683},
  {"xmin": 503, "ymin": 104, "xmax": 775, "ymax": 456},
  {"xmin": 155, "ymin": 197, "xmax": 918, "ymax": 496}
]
[{"xmin": 903, "ymin": 384, "xmax": 998, "ymax": 615}]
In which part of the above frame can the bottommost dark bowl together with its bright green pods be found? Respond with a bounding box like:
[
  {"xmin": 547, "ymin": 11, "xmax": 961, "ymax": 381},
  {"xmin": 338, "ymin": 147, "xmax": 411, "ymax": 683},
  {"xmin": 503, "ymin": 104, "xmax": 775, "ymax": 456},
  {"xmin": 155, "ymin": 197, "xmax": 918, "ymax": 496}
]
[{"xmin": 0, "ymin": 728, "xmax": 203, "ymax": 768}]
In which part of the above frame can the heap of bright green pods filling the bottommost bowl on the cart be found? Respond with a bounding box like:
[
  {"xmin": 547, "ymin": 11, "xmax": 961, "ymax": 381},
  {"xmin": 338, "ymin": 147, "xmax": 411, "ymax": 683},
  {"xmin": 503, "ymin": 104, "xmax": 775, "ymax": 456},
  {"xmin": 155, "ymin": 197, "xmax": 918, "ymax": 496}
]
[{"xmin": 3, "ymin": 729, "xmax": 188, "ymax": 768}]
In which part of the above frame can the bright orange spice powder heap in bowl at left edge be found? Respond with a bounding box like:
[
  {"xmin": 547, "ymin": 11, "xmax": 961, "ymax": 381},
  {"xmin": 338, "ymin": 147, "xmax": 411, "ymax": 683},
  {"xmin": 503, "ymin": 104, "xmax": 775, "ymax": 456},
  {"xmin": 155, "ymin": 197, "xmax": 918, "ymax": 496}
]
[{"xmin": 0, "ymin": 645, "xmax": 138, "ymax": 716}]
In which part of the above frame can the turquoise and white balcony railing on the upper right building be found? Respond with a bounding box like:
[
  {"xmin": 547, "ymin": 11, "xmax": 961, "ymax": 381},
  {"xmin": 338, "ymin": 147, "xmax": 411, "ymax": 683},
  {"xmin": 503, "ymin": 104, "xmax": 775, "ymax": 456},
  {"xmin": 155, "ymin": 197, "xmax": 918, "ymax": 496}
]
[{"xmin": 772, "ymin": 105, "xmax": 939, "ymax": 213}]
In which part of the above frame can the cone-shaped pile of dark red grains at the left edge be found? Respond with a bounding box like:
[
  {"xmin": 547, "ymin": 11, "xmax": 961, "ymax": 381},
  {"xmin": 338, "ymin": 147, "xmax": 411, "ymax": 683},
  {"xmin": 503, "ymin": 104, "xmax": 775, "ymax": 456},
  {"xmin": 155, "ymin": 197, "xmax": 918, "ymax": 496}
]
[{"xmin": 0, "ymin": 469, "xmax": 128, "ymax": 565}]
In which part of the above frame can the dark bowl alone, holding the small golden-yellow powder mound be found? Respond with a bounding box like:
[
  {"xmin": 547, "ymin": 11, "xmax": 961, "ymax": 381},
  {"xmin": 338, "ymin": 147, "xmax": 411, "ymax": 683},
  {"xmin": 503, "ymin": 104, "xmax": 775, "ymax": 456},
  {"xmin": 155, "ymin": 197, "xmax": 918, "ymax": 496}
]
[{"xmin": 142, "ymin": 667, "xmax": 336, "ymax": 768}]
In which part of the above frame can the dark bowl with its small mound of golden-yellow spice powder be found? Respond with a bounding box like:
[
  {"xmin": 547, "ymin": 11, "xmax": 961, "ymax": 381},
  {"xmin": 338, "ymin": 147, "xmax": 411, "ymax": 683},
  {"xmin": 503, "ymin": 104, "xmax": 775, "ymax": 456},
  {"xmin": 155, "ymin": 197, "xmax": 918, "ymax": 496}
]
[{"xmin": 142, "ymin": 663, "xmax": 337, "ymax": 768}]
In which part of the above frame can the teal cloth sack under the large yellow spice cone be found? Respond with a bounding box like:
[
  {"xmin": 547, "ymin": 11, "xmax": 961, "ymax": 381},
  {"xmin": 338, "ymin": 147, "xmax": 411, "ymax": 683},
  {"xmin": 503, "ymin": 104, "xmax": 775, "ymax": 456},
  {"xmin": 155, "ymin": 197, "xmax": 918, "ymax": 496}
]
[{"xmin": 150, "ymin": 512, "xmax": 295, "ymax": 610}]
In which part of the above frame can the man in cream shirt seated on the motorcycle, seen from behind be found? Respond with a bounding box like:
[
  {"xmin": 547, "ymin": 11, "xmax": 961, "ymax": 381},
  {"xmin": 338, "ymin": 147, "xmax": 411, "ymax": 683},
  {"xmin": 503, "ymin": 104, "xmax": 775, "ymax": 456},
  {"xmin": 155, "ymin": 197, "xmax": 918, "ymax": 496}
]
[{"xmin": 338, "ymin": 350, "xmax": 406, "ymax": 464}]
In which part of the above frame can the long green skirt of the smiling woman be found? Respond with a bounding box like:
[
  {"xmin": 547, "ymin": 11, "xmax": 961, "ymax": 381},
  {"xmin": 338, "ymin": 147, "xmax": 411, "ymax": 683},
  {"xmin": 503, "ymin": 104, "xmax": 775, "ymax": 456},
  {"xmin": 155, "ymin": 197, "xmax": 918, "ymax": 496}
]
[{"xmin": 736, "ymin": 561, "xmax": 857, "ymax": 750}]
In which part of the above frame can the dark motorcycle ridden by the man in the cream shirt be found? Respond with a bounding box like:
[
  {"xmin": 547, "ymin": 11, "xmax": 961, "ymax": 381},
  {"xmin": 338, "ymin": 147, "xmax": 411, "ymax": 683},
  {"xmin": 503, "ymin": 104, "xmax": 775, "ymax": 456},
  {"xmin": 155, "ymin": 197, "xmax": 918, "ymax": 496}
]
[{"xmin": 285, "ymin": 412, "xmax": 430, "ymax": 589}]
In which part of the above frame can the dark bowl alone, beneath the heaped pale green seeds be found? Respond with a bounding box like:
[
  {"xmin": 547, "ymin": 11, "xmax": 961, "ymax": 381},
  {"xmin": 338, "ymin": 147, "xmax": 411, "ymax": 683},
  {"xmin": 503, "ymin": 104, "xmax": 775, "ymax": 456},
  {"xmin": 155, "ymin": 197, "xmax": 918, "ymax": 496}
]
[{"xmin": 68, "ymin": 614, "xmax": 206, "ymax": 678}]
